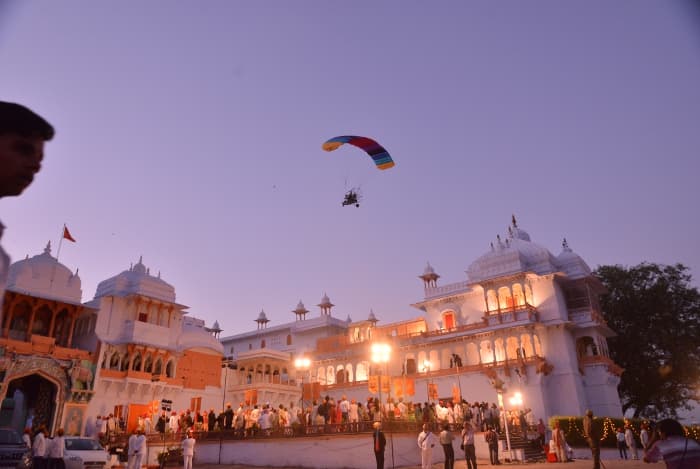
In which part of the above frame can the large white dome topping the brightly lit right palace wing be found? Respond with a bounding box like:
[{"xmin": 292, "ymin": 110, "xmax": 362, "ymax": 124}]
[{"xmin": 467, "ymin": 218, "xmax": 558, "ymax": 283}]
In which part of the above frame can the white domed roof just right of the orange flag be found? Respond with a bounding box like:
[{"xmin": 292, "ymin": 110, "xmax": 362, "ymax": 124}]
[{"xmin": 95, "ymin": 256, "xmax": 175, "ymax": 303}]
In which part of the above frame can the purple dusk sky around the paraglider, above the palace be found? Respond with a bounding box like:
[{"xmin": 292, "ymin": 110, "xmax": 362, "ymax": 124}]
[{"xmin": 0, "ymin": 0, "xmax": 700, "ymax": 335}]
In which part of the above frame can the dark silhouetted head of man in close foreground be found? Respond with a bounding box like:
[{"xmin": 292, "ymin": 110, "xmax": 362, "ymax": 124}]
[{"xmin": 0, "ymin": 101, "xmax": 54, "ymax": 328}]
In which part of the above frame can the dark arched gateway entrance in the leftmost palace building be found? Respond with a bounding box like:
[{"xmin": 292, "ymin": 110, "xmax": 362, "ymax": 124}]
[{"xmin": 6, "ymin": 374, "xmax": 57, "ymax": 431}]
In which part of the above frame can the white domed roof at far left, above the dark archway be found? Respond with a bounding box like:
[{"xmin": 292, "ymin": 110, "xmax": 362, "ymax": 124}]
[{"xmin": 7, "ymin": 241, "xmax": 83, "ymax": 303}]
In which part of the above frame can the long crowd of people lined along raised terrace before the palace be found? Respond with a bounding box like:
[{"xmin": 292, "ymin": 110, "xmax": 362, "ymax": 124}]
[{"xmin": 101, "ymin": 395, "xmax": 533, "ymax": 438}]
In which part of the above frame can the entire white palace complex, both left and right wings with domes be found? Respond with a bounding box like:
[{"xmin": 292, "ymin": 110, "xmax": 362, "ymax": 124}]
[{"xmin": 0, "ymin": 220, "xmax": 622, "ymax": 434}]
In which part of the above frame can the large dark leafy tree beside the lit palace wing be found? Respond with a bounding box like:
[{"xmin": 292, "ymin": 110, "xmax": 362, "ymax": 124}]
[{"xmin": 595, "ymin": 263, "xmax": 700, "ymax": 418}]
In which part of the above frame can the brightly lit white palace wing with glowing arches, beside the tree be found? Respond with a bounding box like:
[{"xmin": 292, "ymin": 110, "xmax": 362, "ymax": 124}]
[{"xmin": 221, "ymin": 218, "xmax": 622, "ymax": 419}]
